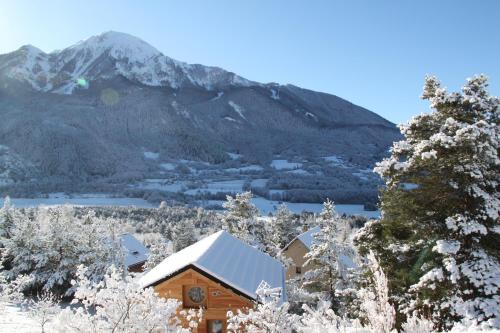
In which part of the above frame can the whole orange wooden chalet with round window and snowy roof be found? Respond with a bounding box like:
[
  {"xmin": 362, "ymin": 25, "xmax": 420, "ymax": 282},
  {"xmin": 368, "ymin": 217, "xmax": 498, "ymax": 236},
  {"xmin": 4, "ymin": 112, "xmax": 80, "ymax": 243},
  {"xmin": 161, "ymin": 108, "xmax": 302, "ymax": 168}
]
[{"xmin": 140, "ymin": 231, "xmax": 286, "ymax": 333}]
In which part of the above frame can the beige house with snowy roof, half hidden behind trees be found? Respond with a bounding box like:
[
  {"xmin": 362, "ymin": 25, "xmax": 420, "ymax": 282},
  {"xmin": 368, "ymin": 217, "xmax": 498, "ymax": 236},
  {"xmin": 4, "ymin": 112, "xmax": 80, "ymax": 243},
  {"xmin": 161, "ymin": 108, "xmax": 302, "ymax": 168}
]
[{"xmin": 283, "ymin": 227, "xmax": 321, "ymax": 280}]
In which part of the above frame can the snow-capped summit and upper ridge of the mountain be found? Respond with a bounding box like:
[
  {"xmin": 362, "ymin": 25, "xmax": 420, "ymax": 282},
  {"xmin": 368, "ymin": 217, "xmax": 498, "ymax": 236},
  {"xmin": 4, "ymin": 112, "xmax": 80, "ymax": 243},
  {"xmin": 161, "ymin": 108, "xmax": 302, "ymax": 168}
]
[{"xmin": 0, "ymin": 31, "xmax": 253, "ymax": 94}]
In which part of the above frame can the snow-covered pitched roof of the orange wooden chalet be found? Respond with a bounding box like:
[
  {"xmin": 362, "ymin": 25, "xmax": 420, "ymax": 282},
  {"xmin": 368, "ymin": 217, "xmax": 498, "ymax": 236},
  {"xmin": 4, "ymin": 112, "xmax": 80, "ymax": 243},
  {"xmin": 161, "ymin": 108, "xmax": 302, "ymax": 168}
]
[{"xmin": 140, "ymin": 231, "xmax": 285, "ymax": 300}]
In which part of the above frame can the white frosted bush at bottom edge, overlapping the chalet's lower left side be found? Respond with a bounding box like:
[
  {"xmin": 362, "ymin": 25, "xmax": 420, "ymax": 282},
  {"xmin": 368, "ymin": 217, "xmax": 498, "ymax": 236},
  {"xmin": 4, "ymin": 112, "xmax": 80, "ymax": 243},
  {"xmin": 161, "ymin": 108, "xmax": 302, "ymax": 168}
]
[{"xmin": 58, "ymin": 266, "xmax": 201, "ymax": 333}]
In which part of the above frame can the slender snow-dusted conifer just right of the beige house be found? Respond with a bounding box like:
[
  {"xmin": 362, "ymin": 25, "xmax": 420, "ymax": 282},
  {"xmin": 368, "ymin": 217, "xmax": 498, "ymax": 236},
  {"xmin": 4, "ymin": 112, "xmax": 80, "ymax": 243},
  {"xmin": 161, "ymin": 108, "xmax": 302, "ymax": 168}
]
[{"xmin": 304, "ymin": 200, "xmax": 349, "ymax": 309}]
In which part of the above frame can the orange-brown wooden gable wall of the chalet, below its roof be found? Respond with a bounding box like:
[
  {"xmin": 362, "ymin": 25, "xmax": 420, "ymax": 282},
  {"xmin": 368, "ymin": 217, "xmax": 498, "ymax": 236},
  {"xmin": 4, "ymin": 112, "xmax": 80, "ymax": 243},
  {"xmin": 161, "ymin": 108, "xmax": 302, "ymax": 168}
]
[{"xmin": 154, "ymin": 269, "xmax": 253, "ymax": 333}]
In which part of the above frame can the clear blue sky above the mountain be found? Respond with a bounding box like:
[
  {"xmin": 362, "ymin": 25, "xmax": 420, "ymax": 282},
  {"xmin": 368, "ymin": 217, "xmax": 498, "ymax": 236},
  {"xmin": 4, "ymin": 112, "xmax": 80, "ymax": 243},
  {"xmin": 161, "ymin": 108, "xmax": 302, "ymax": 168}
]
[{"xmin": 0, "ymin": 0, "xmax": 500, "ymax": 122}]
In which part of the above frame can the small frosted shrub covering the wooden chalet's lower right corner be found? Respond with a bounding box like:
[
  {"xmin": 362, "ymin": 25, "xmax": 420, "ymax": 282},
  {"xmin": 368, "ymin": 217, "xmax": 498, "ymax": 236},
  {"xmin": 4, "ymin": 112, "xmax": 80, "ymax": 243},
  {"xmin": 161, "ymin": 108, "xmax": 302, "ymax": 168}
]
[{"xmin": 227, "ymin": 284, "xmax": 298, "ymax": 333}]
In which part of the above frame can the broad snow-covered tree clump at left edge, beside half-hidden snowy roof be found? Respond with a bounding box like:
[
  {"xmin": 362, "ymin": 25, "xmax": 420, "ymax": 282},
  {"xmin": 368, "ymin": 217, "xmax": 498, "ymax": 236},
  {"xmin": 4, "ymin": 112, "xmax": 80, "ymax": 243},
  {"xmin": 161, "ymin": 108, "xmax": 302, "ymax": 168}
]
[{"xmin": 2, "ymin": 206, "xmax": 123, "ymax": 295}]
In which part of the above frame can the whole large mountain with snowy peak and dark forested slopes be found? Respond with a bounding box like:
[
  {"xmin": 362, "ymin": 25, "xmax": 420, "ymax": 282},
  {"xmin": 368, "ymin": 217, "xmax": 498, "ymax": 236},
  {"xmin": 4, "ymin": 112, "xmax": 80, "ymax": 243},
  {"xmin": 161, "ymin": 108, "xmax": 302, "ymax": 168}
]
[{"xmin": 0, "ymin": 32, "xmax": 399, "ymax": 202}]
